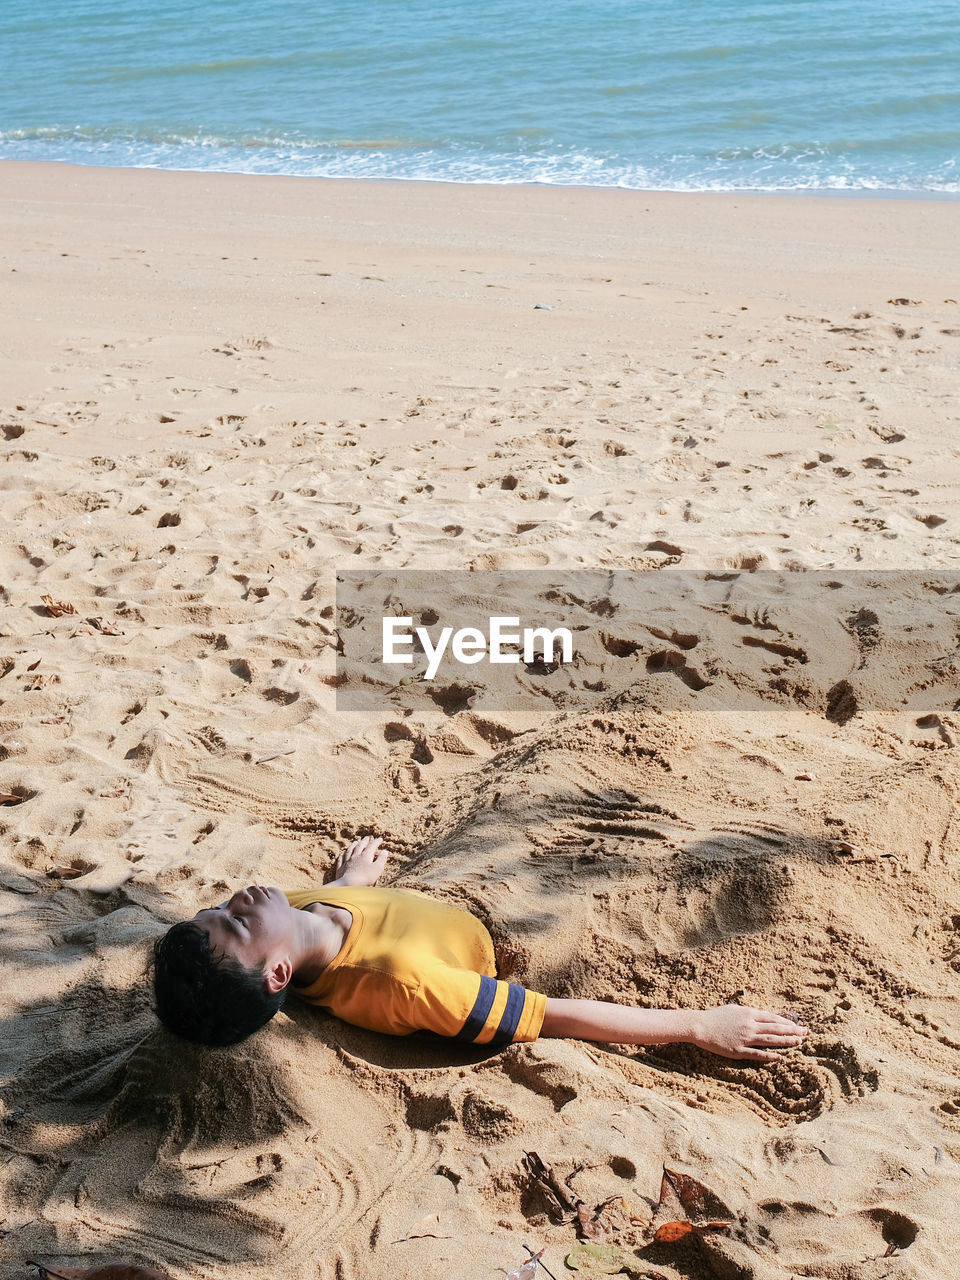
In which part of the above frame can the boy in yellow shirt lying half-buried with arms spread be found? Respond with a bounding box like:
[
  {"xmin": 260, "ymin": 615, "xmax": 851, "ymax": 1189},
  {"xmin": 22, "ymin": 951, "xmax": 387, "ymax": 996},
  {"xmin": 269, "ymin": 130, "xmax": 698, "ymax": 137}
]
[{"xmin": 154, "ymin": 836, "xmax": 806, "ymax": 1062}]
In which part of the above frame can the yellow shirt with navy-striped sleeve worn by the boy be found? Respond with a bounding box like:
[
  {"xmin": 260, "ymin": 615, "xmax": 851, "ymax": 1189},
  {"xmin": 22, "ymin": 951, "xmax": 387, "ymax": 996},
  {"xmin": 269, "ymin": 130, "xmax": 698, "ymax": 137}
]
[{"xmin": 285, "ymin": 886, "xmax": 547, "ymax": 1046}]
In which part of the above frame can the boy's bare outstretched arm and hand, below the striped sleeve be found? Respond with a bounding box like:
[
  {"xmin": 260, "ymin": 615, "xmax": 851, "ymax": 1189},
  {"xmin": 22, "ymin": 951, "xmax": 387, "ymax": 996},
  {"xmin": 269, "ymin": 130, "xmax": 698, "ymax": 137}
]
[{"xmin": 540, "ymin": 997, "xmax": 806, "ymax": 1062}]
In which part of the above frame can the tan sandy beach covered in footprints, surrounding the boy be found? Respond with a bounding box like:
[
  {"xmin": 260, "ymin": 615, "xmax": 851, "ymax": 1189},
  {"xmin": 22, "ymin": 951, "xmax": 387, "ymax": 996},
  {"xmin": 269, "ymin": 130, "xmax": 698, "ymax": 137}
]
[{"xmin": 0, "ymin": 164, "xmax": 960, "ymax": 1280}]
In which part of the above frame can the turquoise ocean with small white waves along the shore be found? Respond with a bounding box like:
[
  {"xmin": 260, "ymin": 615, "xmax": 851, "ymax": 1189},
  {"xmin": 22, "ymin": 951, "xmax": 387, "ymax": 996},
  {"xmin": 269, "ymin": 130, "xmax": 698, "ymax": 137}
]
[{"xmin": 0, "ymin": 0, "xmax": 960, "ymax": 195}]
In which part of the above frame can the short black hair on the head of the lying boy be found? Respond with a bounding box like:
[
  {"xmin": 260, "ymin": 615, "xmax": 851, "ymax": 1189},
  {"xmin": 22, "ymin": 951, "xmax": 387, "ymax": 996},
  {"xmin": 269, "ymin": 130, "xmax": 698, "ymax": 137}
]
[{"xmin": 154, "ymin": 920, "xmax": 287, "ymax": 1044}]
